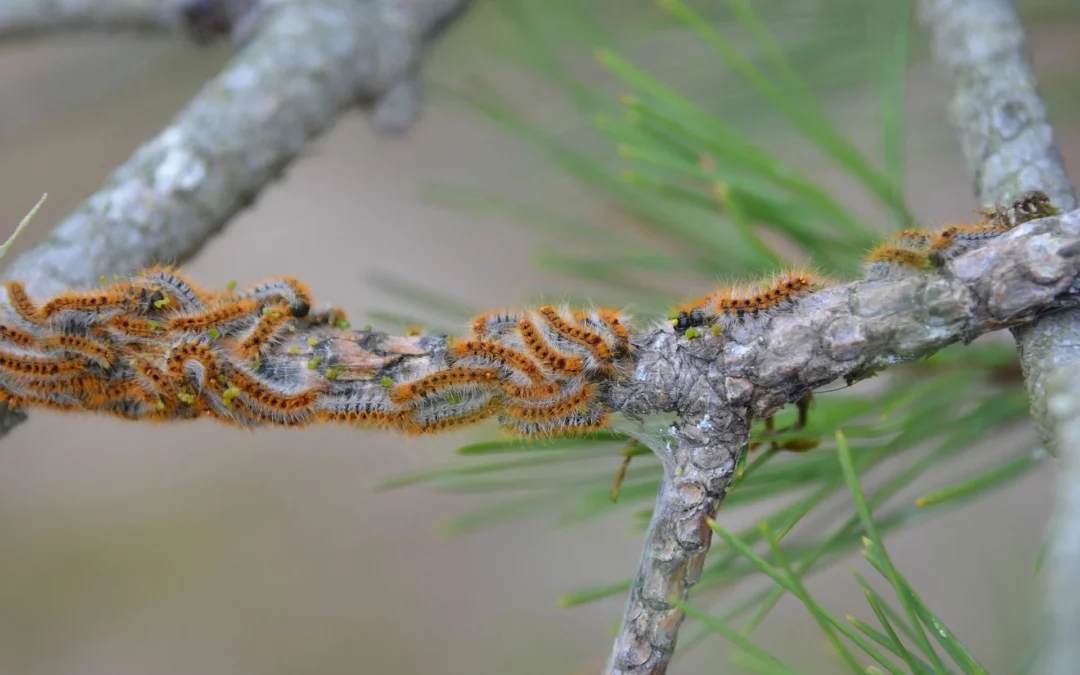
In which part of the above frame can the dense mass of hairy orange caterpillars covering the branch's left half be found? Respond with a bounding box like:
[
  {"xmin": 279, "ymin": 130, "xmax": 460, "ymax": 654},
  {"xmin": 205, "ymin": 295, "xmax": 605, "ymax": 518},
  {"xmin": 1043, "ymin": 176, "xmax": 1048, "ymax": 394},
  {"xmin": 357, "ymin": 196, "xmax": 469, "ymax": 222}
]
[{"xmin": 0, "ymin": 267, "xmax": 631, "ymax": 436}]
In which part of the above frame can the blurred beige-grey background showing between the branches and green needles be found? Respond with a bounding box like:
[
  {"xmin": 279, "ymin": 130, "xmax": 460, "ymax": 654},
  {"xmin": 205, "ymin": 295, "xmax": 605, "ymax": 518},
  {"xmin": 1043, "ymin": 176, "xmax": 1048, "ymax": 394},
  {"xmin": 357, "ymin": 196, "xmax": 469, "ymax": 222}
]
[{"xmin": 0, "ymin": 5, "xmax": 1080, "ymax": 675}]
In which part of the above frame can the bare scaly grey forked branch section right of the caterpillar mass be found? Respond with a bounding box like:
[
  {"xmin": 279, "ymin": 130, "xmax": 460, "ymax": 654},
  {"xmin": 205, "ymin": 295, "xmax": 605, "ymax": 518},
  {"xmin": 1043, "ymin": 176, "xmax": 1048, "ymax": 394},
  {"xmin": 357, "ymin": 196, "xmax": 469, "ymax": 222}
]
[{"xmin": 608, "ymin": 211, "xmax": 1080, "ymax": 675}]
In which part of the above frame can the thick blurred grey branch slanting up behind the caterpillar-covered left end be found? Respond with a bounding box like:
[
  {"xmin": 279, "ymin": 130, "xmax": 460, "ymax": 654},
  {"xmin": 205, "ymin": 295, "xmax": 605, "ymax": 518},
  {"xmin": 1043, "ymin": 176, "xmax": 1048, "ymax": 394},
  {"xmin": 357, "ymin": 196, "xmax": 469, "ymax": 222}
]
[{"xmin": 0, "ymin": 0, "xmax": 468, "ymax": 435}]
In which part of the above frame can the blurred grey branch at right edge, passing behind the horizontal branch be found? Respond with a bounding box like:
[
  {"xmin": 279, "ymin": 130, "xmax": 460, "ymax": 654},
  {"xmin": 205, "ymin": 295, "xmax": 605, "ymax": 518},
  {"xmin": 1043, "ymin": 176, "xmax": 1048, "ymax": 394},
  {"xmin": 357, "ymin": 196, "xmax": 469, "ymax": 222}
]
[{"xmin": 919, "ymin": 0, "xmax": 1080, "ymax": 675}]
